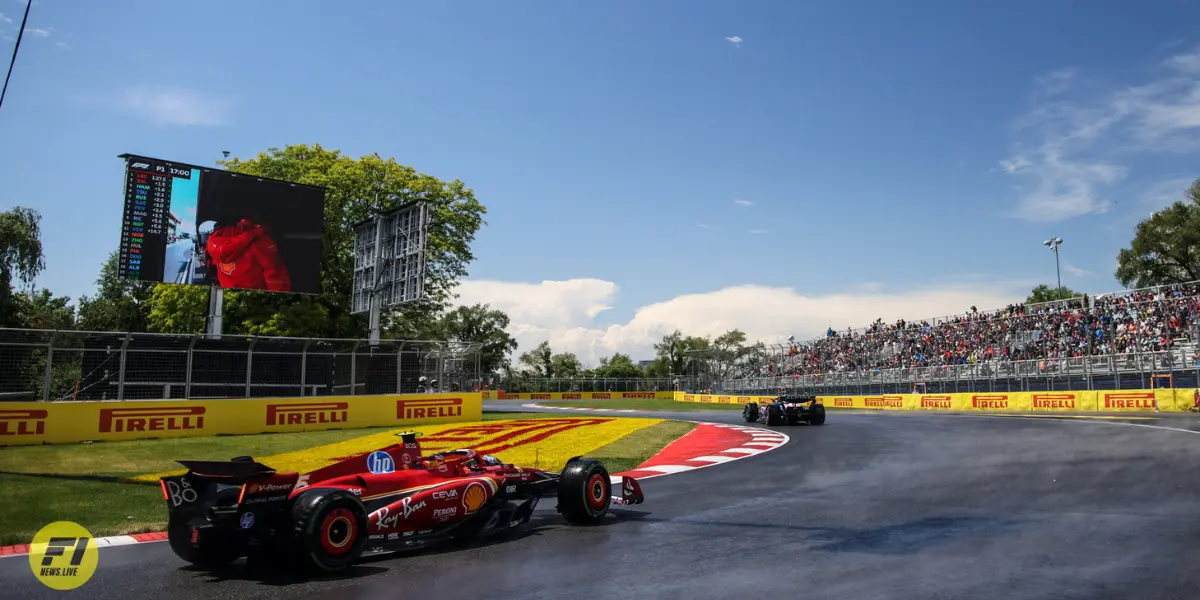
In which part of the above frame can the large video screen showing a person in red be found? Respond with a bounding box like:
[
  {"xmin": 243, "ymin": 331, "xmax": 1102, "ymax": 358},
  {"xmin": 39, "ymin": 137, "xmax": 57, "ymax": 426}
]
[{"xmin": 119, "ymin": 155, "xmax": 325, "ymax": 294}]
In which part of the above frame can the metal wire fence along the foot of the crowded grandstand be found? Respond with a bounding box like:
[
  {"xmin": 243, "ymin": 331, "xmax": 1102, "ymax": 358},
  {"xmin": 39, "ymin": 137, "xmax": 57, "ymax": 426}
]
[{"xmin": 710, "ymin": 348, "xmax": 1200, "ymax": 395}]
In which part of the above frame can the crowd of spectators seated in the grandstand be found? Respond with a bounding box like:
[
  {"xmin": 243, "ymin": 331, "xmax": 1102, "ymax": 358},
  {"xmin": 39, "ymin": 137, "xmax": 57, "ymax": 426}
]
[{"xmin": 745, "ymin": 286, "xmax": 1200, "ymax": 377}]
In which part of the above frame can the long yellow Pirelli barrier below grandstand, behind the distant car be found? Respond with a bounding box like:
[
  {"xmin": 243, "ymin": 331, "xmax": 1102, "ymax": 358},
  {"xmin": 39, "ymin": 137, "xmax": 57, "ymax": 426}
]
[{"xmin": 676, "ymin": 388, "xmax": 1195, "ymax": 413}]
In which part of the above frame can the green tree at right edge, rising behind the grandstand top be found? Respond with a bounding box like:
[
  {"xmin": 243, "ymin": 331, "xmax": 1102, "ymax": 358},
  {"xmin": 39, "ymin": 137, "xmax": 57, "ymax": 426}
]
[{"xmin": 1115, "ymin": 179, "xmax": 1200, "ymax": 288}]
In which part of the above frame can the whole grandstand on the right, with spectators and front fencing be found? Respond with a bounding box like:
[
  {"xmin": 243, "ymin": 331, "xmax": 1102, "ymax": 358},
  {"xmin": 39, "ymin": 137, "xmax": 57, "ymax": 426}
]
[{"xmin": 712, "ymin": 283, "xmax": 1200, "ymax": 394}]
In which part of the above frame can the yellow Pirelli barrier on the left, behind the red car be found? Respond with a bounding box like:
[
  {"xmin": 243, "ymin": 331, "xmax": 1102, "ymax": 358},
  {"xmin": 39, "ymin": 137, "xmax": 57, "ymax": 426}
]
[{"xmin": 0, "ymin": 392, "xmax": 484, "ymax": 446}]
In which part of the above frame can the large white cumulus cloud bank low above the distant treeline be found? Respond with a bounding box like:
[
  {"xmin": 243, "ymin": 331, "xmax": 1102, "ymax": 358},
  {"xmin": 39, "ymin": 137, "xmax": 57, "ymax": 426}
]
[{"xmin": 457, "ymin": 278, "xmax": 1030, "ymax": 366}]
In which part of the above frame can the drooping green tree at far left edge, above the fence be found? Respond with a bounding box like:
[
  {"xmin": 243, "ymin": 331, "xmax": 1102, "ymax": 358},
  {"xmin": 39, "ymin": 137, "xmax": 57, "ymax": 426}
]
[{"xmin": 0, "ymin": 206, "xmax": 46, "ymax": 328}]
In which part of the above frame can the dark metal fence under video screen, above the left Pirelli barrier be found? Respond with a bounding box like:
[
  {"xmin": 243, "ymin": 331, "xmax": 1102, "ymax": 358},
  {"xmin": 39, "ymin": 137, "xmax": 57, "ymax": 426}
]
[{"xmin": 0, "ymin": 329, "xmax": 481, "ymax": 401}]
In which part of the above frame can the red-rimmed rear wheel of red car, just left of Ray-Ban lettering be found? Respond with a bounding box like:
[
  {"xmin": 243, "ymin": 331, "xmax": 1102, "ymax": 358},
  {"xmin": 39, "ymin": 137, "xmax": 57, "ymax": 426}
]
[{"xmin": 292, "ymin": 490, "xmax": 367, "ymax": 574}]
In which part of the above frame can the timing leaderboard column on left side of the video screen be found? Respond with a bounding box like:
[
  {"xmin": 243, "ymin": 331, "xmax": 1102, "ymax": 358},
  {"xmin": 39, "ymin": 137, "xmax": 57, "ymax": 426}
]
[{"xmin": 118, "ymin": 157, "xmax": 192, "ymax": 282}]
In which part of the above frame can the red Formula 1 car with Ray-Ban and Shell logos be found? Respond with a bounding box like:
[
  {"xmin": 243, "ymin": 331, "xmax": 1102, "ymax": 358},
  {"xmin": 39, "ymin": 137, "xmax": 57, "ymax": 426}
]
[{"xmin": 161, "ymin": 433, "xmax": 643, "ymax": 572}]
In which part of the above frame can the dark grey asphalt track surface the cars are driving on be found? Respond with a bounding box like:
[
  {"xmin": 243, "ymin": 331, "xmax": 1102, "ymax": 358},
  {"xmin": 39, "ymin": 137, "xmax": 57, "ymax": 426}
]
[{"xmin": 7, "ymin": 404, "xmax": 1200, "ymax": 600}]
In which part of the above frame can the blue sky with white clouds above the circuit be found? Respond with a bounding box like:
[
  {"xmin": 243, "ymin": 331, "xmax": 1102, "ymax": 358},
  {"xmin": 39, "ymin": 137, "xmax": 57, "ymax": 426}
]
[{"xmin": 0, "ymin": 0, "xmax": 1200, "ymax": 359}]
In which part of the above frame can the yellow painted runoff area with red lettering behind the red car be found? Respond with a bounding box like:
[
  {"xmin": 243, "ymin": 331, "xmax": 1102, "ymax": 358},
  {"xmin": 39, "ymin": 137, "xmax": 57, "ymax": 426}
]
[{"xmin": 134, "ymin": 418, "xmax": 662, "ymax": 481}]
